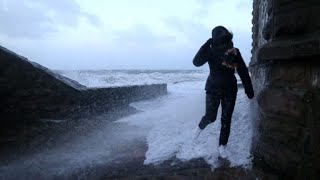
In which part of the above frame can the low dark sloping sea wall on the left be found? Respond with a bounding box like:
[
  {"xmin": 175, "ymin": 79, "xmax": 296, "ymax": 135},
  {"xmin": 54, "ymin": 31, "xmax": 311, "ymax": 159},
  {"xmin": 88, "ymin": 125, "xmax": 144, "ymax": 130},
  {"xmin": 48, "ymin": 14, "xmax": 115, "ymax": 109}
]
[{"xmin": 0, "ymin": 46, "xmax": 167, "ymax": 134}]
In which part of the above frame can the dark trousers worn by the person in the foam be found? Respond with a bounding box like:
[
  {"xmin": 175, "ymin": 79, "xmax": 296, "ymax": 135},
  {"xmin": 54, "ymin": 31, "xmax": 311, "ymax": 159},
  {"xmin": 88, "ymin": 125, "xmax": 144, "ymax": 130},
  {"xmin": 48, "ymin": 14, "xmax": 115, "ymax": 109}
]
[{"xmin": 199, "ymin": 88, "xmax": 237, "ymax": 145}]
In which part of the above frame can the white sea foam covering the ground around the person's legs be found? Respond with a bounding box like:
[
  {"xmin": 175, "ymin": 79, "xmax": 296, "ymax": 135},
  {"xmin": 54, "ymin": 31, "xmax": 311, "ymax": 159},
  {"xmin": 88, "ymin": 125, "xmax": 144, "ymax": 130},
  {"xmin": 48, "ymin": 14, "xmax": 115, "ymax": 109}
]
[{"xmin": 118, "ymin": 82, "xmax": 252, "ymax": 168}]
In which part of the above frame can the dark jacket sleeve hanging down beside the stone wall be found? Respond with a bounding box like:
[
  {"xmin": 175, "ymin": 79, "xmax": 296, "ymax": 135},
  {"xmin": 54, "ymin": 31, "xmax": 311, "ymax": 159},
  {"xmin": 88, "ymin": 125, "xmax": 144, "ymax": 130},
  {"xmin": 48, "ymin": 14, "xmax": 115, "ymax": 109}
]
[{"xmin": 237, "ymin": 50, "xmax": 254, "ymax": 99}]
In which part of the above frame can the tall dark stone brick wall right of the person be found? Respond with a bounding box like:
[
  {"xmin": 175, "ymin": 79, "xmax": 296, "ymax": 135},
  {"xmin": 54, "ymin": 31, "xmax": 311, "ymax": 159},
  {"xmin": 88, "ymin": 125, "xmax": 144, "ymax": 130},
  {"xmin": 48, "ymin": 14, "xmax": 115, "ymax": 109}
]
[{"xmin": 250, "ymin": 0, "xmax": 320, "ymax": 177}]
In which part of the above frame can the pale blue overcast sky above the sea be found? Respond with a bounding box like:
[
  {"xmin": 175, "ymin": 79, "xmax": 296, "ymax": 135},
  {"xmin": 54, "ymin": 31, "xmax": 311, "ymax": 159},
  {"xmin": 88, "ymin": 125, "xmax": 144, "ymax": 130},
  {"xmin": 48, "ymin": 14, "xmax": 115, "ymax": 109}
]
[{"xmin": 0, "ymin": 0, "xmax": 252, "ymax": 69}]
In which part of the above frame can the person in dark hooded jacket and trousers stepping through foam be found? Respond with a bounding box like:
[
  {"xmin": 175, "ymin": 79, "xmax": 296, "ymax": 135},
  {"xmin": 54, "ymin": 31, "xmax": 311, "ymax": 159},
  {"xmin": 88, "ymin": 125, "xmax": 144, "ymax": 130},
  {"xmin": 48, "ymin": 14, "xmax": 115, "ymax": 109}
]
[{"xmin": 193, "ymin": 26, "xmax": 254, "ymax": 158}]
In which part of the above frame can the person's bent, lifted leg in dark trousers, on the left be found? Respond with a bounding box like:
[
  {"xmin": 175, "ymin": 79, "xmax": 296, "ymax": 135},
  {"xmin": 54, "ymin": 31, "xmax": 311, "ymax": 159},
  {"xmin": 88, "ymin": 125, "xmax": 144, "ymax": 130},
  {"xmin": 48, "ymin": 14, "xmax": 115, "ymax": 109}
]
[{"xmin": 198, "ymin": 92, "xmax": 220, "ymax": 129}]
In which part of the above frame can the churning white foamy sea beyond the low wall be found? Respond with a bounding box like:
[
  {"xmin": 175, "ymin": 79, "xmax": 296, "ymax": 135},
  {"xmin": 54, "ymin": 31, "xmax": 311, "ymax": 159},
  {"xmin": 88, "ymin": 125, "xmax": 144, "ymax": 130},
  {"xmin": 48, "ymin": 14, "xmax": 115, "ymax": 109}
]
[{"xmin": 57, "ymin": 70, "xmax": 208, "ymax": 87}]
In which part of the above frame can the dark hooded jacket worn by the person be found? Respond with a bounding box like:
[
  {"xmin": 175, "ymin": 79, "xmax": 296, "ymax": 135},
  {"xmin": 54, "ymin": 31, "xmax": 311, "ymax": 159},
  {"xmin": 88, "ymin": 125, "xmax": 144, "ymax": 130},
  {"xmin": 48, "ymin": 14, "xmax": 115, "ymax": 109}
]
[{"xmin": 193, "ymin": 26, "xmax": 254, "ymax": 99}]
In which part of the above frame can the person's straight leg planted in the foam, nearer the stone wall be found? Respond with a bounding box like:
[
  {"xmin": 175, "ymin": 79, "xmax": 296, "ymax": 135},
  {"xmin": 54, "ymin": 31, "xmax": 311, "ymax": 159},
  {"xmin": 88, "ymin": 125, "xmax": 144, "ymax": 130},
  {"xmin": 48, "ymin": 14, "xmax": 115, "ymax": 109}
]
[{"xmin": 219, "ymin": 90, "xmax": 237, "ymax": 146}]
